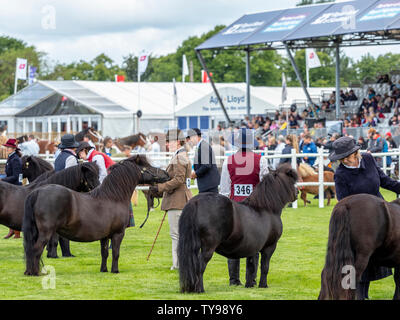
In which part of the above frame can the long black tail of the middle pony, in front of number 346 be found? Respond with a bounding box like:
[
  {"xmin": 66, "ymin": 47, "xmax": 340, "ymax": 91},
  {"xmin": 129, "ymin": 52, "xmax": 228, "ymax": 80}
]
[{"xmin": 178, "ymin": 202, "xmax": 204, "ymax": 293}]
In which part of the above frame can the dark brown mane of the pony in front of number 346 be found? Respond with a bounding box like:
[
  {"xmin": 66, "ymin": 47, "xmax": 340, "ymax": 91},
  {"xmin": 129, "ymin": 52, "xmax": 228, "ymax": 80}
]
[{"xmin": 241, "ymin": 164, "xmax": 298, "ymax": 213}]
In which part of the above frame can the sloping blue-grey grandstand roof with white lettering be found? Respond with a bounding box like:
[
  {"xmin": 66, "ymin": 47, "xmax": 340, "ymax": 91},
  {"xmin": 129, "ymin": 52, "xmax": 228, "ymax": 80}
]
[{"xmin": 196, "ymin": 0, "xmax": 400, "ymax": 50}]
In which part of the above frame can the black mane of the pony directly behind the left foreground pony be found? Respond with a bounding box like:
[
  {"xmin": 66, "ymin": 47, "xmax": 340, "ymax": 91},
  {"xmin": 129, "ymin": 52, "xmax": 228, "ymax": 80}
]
[{"xmin": 32, "ymin": 162, "xmax": 99, "ymax": 188}]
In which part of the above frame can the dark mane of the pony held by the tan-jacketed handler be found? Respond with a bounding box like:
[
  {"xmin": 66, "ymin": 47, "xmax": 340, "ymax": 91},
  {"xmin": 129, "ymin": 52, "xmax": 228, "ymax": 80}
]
[{"xmin": 89, "ymin": 156, "xmax": 141, "ymax": 202}]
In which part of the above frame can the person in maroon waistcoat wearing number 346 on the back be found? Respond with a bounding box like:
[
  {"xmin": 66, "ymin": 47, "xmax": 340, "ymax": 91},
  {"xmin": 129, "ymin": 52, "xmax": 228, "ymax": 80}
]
[{"xmin": 220, "ymin": 128, "xmax": 268, "ymax": 286}]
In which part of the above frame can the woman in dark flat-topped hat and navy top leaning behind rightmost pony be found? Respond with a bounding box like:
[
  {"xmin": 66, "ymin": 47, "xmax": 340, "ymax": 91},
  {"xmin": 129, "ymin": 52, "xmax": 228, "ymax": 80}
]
[{"xmin": 329, "ymin": 137, "xmax": 400, "ymax": 299}]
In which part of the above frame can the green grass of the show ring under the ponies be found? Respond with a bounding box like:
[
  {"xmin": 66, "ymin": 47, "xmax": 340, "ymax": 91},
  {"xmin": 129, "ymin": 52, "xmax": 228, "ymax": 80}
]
[{"xmin": 0, "ymin": 192, "xmax": 395, "ymax": 300}]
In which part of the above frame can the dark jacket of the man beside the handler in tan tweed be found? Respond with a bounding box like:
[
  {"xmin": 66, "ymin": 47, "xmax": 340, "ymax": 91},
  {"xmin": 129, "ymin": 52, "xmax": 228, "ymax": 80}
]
[{"xmin": 193, "ymin": 140, "xmax": 220, "ymax": 192}]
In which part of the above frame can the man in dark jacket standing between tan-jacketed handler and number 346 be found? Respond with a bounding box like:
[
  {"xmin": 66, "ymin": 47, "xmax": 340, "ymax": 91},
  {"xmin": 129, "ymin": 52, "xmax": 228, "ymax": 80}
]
[{"xmin": 188, "ymin": 128, "xmax": 220, "ymax": 193}]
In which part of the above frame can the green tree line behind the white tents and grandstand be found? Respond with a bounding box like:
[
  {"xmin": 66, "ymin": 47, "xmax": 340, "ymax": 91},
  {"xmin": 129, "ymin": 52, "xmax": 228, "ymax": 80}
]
[{"xmin": 0, "ymin": 25, "xmax": 400, "ymax": 101}]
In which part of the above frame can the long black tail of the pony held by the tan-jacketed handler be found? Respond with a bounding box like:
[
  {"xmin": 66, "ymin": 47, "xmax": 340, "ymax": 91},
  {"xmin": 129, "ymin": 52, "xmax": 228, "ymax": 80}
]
[{"xmin": 22, "ymin": 192, "xmax": 39, "ymax": 275}]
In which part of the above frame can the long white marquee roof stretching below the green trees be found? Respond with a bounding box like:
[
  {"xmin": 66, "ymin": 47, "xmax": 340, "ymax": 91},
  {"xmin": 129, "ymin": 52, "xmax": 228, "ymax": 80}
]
[{"xmin": 0, "ymin": 80, "xmax": 334, "ymax": 119}]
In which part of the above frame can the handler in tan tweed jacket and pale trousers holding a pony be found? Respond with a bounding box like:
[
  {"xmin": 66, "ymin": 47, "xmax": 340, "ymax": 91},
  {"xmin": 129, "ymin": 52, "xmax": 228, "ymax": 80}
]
[{"xmin": 150, "ymin": 129, "xmax": 192, "ymax": 270}]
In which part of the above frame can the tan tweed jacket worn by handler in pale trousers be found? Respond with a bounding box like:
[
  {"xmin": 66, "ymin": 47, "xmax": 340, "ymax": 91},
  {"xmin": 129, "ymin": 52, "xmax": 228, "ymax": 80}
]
[{"xmin": 158, "ymin": 148, "xmax": 192, "ymax": 211}]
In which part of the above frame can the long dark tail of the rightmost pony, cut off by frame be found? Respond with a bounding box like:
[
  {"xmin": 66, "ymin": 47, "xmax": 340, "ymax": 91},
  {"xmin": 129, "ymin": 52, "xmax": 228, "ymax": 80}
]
[{"xmin": 319, "ymin": 203, "xmax": 355, "ymax": 299}]
